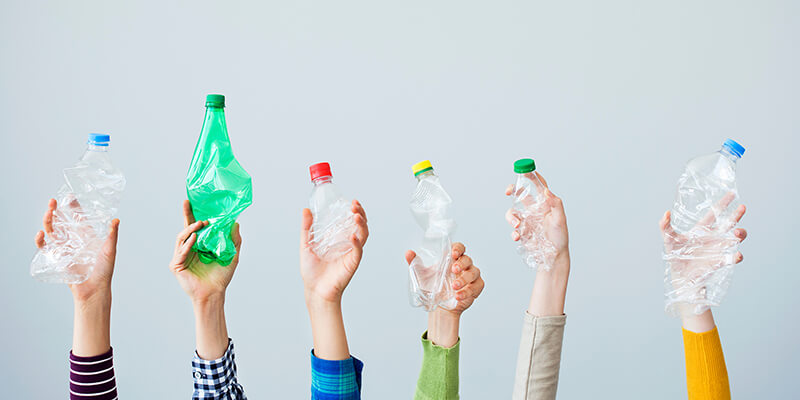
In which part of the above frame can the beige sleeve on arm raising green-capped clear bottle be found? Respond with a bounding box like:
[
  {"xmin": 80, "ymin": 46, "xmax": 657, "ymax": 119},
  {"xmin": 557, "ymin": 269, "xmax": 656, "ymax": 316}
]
[{"xmin": 512, "ymin": 312, "xmax": 567, "ymax": 400}]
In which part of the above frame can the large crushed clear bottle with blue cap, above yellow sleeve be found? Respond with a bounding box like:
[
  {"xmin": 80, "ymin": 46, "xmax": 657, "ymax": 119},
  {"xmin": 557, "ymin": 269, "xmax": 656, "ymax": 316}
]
[{"xmin": 664, "ymin": 139, "xmax": 745, "ymax": 315}]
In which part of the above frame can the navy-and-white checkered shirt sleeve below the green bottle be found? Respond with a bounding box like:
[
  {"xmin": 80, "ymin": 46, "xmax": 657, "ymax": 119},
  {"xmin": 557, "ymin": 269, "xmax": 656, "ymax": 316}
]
[{"xmin": 192, "ymin": 339, "xmax": 247, "ymax": 400}]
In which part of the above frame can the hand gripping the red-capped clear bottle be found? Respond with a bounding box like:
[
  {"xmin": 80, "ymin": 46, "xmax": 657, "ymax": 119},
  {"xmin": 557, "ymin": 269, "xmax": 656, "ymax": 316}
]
[{"xmin": 300, "ymin": 200, "xmax": 369, "ymax": 303}]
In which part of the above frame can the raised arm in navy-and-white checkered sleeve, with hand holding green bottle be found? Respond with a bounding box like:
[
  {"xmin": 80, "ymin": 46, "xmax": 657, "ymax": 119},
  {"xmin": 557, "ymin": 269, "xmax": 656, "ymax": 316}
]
[{"xmin": 170, "ymin": 200, "xmax": 246, "ymax": 400}]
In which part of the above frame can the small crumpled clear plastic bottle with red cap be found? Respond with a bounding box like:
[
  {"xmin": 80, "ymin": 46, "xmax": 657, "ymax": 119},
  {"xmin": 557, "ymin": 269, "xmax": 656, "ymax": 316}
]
[{"xmin": 309, "ymin": 162, "xmax": 356, "ymax": 259}]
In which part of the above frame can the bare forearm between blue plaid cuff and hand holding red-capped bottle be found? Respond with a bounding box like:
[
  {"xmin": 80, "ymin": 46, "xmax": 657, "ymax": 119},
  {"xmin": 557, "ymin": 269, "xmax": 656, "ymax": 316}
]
[{"xmin": 306, "ymin": 294, "xmax": 350, "ymax": 360}]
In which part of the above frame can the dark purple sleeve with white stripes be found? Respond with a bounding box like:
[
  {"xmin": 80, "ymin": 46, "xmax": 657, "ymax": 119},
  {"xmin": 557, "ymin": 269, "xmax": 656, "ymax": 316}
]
[{"xmin": 69, "ymin": 349, "xmax": 117, "ymax": 400}]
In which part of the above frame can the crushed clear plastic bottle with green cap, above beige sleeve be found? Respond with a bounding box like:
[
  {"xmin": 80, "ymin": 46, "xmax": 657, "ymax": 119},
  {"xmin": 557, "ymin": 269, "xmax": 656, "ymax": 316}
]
[{"xmin": 511, "ymin": 158, "xmax": 556, "ymax": 271}]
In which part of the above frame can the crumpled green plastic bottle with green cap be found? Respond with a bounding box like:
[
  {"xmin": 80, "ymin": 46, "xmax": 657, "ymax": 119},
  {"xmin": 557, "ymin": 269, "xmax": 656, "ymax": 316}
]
[{"xmin": 186, "ymin": 94, "xmax": 253, "ymax": 266}]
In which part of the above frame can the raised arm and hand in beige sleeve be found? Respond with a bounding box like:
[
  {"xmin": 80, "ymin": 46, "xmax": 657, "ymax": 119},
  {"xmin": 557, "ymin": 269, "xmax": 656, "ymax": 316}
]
[{"xmin": 506, "ymin": 172, "xmax": 570, "ymax": 400}]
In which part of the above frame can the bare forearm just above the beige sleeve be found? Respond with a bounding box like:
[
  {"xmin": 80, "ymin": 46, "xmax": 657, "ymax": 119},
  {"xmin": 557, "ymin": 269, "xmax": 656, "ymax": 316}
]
[{"xmin": 528, "ymin": 252, "xmax": 570, "ymax": 317}]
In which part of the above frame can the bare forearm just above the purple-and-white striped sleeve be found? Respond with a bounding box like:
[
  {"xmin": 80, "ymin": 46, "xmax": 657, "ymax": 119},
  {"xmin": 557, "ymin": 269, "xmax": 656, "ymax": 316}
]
[{"xmin": 72, "ymin": 288, "xmax": 111, "ymax": 357}]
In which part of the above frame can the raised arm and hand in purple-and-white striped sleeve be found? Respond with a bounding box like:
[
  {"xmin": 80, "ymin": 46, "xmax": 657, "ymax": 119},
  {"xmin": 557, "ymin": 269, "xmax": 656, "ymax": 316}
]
[{"xmin": 35, "ymin": 199, "xmax": 119, "ymax": 400}]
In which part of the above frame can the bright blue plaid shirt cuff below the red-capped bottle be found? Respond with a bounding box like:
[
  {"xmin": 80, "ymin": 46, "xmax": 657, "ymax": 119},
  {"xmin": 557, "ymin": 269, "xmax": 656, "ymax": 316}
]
[{"xmin": 311, "ymin": 350, "xmax": 364, "ymax": 400}]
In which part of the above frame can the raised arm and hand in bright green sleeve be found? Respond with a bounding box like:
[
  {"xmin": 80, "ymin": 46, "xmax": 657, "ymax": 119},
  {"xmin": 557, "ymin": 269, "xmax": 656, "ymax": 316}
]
[{"xmin": 406, "ymin": 243, "xmax": 485, "ymax": 400}]
